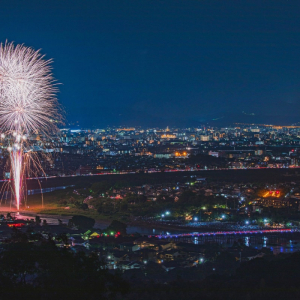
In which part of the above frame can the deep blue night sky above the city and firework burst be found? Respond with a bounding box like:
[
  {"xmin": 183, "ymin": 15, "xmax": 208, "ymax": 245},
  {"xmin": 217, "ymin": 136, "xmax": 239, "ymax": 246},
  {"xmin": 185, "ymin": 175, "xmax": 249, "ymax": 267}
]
[{"xmin": 0, "ymin": 0, "xmax": 300, "ymax": 127}]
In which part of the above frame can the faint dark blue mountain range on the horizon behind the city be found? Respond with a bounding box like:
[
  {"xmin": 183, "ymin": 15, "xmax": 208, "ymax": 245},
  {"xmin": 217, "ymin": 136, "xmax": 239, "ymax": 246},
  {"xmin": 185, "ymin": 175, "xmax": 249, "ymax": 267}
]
[{"xmin": 66, "ymin": 107, "xmax": 300, "ymax": 128}]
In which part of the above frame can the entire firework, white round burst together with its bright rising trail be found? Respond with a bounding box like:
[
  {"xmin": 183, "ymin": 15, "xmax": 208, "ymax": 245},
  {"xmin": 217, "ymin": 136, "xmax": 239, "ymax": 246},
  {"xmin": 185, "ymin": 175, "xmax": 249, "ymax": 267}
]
[{"xmin": 0, "ymin": 43, "xmax": 60, "ymax": 210}]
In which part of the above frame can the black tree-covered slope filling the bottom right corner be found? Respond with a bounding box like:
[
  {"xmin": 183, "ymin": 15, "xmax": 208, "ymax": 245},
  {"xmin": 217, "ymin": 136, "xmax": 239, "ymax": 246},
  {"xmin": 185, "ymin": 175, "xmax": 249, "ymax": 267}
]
[{"xmin": 126, "ymin": 253, "xmax": 300, "ymax": 300}]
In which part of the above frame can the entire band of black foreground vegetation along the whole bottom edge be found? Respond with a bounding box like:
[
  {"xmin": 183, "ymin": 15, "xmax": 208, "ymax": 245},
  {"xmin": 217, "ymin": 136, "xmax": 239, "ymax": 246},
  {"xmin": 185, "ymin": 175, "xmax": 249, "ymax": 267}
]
[{"xmin": 0, "ymin": 230, "xmax": 300, "ymax": 300}]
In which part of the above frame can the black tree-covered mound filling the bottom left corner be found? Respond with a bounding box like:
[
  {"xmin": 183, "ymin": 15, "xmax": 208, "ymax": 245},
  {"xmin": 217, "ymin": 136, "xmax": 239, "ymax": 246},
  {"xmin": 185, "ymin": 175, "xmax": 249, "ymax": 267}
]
[{"xmin": 0, "ymin": 230, "xmax": 129, "ymax": 299}]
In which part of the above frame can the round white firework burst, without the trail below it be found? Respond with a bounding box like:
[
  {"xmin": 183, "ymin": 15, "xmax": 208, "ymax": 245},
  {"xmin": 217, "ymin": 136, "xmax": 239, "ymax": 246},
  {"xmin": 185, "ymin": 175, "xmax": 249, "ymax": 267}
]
[{"xmin": 0, "ymin": 43, "xmax": 59, "ymax": 134}]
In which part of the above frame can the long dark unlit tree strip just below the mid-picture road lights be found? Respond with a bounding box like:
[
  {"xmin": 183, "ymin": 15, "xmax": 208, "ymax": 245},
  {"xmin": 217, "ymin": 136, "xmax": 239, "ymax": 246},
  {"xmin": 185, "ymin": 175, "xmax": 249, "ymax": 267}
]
[{"xmin": 14, "ymin": 169, "xmax": 300, "ymax": 189}]
